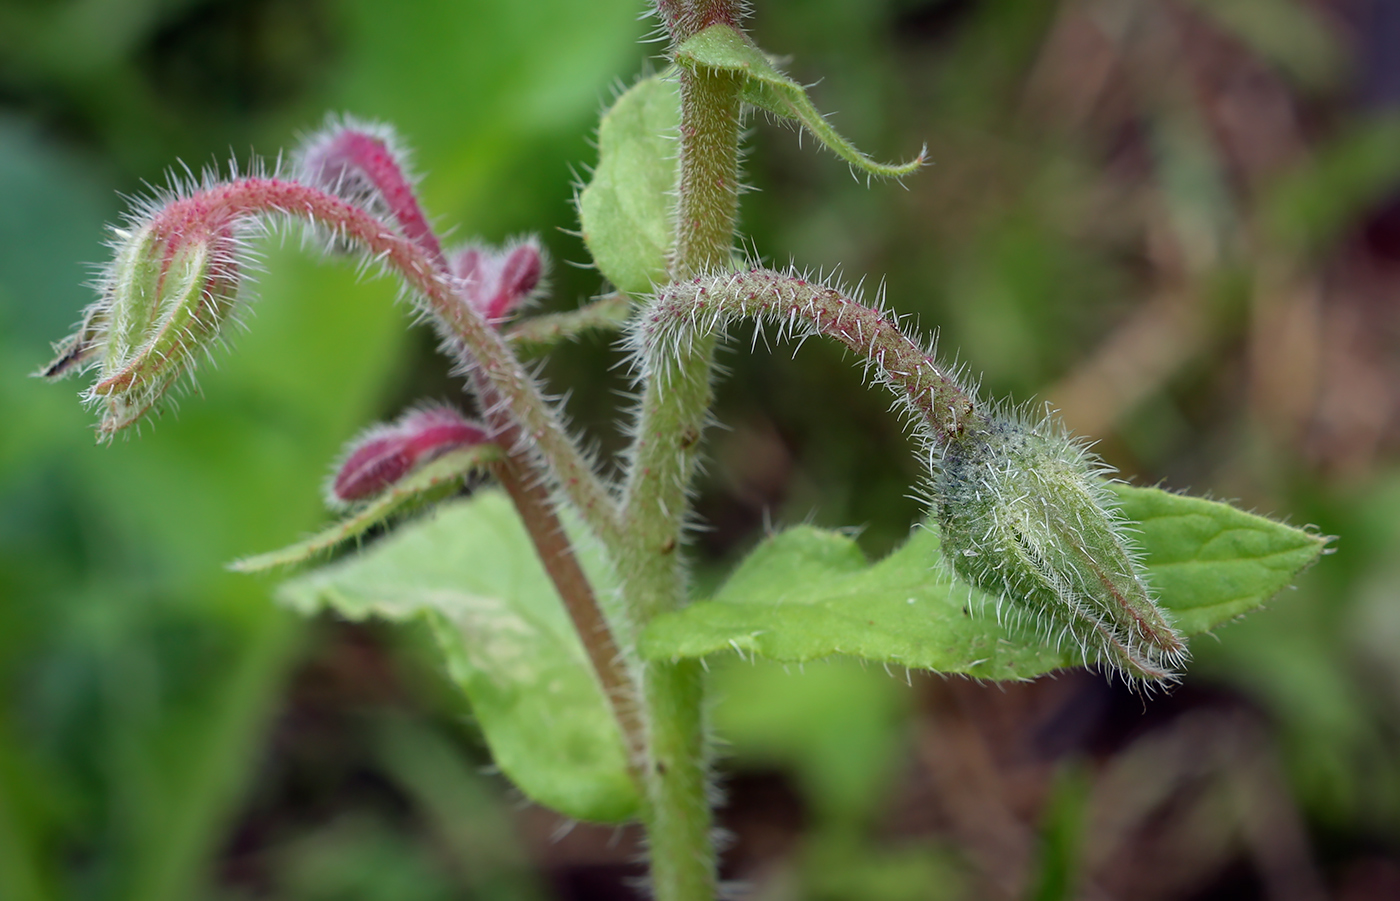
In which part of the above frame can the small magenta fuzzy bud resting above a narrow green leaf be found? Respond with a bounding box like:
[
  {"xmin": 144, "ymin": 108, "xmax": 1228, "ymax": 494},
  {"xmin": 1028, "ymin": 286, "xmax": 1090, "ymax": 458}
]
[{"xmin": 326, "ymin": 407, "xmax": 490, "ymax": 508}]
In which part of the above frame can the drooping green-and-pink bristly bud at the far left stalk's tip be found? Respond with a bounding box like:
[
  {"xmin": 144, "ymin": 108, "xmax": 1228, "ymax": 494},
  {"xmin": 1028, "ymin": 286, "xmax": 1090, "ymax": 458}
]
[{"xmin": 41, "ymin": 207, "xmax": 241, "ymax": 435}]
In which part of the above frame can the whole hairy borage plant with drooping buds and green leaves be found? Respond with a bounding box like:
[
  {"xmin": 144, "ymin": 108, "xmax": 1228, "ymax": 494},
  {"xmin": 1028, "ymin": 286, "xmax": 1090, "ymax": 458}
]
[{"xmin": 43, "ymin": 0, "xmax": 1326, "ymax": 901}]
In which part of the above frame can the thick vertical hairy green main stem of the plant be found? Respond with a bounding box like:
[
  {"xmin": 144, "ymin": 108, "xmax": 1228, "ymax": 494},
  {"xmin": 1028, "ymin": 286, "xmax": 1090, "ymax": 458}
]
[{"xmin": 620, "ymin": 10, "xmax": 741, "ymax": 901}]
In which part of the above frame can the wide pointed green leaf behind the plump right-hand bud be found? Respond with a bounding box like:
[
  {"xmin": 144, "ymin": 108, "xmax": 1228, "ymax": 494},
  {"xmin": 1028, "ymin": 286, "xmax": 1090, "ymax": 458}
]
[{"xmin": 641, "ymin": 485, "xmax": 1327, "ymax": 679}]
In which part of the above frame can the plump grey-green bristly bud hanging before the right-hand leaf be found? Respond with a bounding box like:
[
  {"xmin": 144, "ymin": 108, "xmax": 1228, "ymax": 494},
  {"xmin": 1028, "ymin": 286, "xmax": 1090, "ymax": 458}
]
[{"xmin": 934, "ymin": 420, "xmax": 1186, "ymax": 680}]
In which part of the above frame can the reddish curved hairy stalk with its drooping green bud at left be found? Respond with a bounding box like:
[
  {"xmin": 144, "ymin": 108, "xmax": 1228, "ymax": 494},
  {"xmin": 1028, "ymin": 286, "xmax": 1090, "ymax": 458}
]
[{"xmin": 39, "ymin": 160, "xmax": 616, "ymax": 540}]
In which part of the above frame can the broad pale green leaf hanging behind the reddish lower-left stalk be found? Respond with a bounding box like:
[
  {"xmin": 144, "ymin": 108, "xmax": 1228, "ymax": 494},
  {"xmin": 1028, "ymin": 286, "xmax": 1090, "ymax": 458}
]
[{"xmin": 279, "ymin": 491, "xmax": 637, "ymax": 823}]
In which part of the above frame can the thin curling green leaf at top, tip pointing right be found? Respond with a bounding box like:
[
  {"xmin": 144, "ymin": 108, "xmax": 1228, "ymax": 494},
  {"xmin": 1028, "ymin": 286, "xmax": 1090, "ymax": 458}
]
[{"xmin": 676, "ymin": 25, "xmax": 924, "ymax": 178}]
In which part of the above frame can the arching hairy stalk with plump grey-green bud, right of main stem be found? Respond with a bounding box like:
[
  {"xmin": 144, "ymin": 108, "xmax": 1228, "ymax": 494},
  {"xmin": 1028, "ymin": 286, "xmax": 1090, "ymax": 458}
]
[{"xmin": 631, "ymin": 269, "xmax": 1186, "ymax": 680}]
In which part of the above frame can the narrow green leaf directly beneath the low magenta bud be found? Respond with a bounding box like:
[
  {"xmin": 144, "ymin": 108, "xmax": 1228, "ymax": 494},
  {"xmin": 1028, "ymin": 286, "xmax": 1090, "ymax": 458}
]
[{"xmin": 228, "ymin": 445, "xmax": 501, "ymax": 572}]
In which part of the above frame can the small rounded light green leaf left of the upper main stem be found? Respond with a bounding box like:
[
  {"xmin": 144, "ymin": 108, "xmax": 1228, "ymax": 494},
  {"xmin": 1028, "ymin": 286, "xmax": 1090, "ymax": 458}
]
[{"xmin": 578, "ymin": 76, "xmax": 680, "ymax": 294}]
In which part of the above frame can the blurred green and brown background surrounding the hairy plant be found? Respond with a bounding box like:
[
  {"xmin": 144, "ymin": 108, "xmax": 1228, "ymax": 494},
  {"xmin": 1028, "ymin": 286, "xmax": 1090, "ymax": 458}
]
[{"xmin": 0, "ymin": 0, "xmax": 1400, "ymax": 901}]
